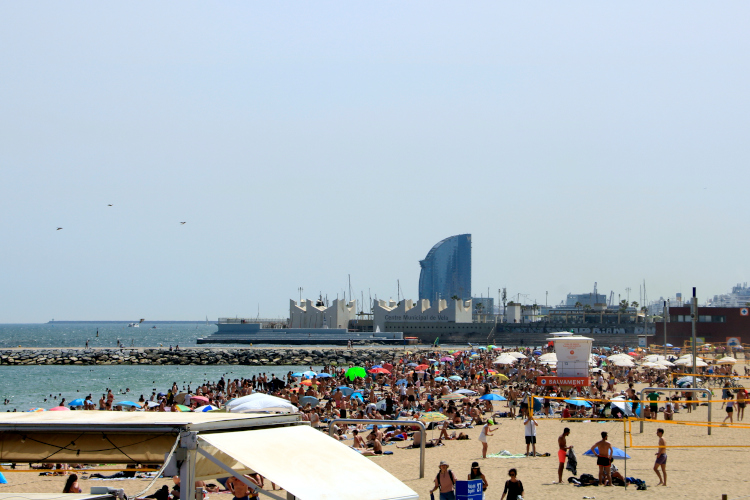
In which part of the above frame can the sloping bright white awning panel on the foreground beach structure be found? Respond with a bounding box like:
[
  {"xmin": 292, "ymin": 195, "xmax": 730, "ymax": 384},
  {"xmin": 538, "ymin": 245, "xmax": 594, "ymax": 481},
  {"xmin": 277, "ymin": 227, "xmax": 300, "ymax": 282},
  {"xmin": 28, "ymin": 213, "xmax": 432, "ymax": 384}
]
[{"xmin": 196, "ymin": 425, "xmax": 419, "ymax": 500}]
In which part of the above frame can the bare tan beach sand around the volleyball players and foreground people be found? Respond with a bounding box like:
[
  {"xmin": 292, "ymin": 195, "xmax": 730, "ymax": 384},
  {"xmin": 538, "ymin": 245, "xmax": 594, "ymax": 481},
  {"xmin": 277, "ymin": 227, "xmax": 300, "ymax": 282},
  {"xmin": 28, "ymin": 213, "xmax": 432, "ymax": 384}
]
[{"xmin": 0, "ymin": 378, "xmax": 750, "ymax": 500}]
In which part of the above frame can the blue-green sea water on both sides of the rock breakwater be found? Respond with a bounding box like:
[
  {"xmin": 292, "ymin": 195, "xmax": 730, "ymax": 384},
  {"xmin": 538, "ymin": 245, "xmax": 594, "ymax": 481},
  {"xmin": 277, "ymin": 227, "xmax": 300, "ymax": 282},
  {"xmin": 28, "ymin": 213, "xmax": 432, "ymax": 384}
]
[{"xmin": 0, "ymin": 321, "xmax": 321, "ymax": 411}]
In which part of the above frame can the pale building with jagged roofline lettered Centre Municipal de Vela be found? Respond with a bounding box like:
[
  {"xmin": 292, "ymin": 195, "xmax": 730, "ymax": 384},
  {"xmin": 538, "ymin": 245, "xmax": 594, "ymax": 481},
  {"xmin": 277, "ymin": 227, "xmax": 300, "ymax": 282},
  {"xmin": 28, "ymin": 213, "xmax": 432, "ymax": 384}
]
[{"xmin": 372, "ymin": 299, "xmax": 471, "ymax": 331}]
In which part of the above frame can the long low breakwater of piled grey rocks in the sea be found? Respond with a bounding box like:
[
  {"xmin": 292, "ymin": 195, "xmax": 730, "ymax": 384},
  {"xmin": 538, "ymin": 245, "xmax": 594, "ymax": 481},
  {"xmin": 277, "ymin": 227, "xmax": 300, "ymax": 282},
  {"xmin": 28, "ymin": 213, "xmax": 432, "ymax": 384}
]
[{"xmin": 0, "ymin": 347, "xmax": 434, "ymax": 366}]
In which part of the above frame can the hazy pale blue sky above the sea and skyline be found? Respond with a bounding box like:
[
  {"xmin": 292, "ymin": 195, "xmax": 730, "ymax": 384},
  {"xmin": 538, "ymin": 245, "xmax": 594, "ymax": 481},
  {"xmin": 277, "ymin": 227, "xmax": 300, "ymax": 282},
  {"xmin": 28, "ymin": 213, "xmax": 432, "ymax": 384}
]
[{"xmin": 0, "ymin": 1, "xmax": 750, "ymax": 323}]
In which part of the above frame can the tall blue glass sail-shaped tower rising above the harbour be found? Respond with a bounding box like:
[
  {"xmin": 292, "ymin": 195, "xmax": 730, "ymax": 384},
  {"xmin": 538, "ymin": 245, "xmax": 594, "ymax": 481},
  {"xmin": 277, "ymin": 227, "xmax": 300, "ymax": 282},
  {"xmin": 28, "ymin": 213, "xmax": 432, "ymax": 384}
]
[{"xmin": 419, "ymin": 234, "xmax": 471, "ymax": 302}]
